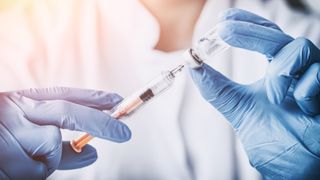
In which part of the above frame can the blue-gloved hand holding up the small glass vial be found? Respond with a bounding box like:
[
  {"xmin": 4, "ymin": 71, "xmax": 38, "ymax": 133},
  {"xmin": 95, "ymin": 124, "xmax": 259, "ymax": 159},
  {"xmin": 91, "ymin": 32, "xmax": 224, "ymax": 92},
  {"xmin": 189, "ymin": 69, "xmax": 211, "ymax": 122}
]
[{"xmin": 190, "ymin": 9, "xmax": 320, "ymax": 179}]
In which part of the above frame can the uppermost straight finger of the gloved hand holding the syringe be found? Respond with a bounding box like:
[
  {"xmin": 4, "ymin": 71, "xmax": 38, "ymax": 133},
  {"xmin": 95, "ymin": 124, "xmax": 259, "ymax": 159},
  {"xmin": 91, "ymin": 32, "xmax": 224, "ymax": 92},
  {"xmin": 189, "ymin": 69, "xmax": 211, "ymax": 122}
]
[{"xmin": 17, "ymin": 87, "xmax": 122, "ymax": 110}]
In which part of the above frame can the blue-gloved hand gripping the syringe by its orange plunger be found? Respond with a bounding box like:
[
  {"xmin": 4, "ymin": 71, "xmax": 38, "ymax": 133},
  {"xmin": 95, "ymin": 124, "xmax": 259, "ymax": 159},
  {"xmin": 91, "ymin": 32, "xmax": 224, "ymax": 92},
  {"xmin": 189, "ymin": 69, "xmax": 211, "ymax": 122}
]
[{"xmin": 0, "ymin": 88, "xmax": 131, "ymax": 179}]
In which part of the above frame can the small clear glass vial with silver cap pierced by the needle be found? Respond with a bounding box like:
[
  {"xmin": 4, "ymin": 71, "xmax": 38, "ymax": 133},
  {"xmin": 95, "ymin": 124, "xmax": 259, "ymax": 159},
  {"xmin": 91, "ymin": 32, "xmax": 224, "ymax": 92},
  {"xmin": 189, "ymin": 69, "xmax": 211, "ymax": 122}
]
[{"xmin": 184, "ymin": 26, "xmax": 230, "ymax": 68}]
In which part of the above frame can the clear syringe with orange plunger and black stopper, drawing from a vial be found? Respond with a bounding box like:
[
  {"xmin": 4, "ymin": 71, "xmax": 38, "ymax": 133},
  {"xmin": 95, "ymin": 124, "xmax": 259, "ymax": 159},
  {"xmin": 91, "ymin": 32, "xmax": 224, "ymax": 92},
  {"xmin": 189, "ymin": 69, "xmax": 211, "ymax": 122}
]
[{"xmin": 70, "ymin": 65, "xmax": 184, "ymax": 153}]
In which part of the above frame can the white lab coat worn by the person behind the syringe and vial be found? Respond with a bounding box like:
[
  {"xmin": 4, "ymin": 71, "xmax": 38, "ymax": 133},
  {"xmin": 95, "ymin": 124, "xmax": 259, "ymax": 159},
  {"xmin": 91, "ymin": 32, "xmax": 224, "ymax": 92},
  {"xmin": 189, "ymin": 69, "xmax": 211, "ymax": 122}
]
[{"xmin": 0, "ymin": 0, "xmax": 319, "ymax": 180}]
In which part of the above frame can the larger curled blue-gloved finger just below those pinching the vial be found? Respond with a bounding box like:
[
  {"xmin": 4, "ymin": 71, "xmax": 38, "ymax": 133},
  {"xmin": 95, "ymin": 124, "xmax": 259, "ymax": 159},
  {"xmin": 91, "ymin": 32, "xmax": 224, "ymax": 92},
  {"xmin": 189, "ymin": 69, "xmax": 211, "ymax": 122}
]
[{"xmin": 265, "ymin": 38, "xmax": 320, "ymax": 104}]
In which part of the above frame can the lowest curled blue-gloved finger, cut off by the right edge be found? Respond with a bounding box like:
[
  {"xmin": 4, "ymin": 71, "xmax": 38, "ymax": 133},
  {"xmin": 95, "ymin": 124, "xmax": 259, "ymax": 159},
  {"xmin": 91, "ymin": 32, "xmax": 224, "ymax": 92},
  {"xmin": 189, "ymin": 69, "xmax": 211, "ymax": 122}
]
[{"xmin": 293, "ymin": 63, "xmax": 320, "ymax": 116}]
